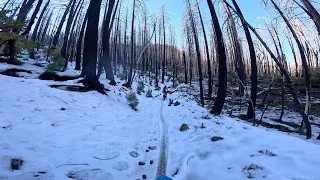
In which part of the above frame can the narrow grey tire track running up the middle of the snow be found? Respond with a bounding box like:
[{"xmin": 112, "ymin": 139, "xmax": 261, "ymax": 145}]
[{"xmin": 156, "ymin": 101, "xmax": 168, "ymax": 179}]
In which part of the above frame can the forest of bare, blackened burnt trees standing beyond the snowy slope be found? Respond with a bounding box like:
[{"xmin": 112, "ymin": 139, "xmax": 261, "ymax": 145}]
[{"xmin": 0, "ymin": 0, "xmax": 320, "ymax": 138}]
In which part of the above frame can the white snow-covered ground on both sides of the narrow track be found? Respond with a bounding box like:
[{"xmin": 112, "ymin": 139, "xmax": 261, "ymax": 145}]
[{"xmin": 0, "ymin": 56, "xmax": 320, "ymax": 180}]
